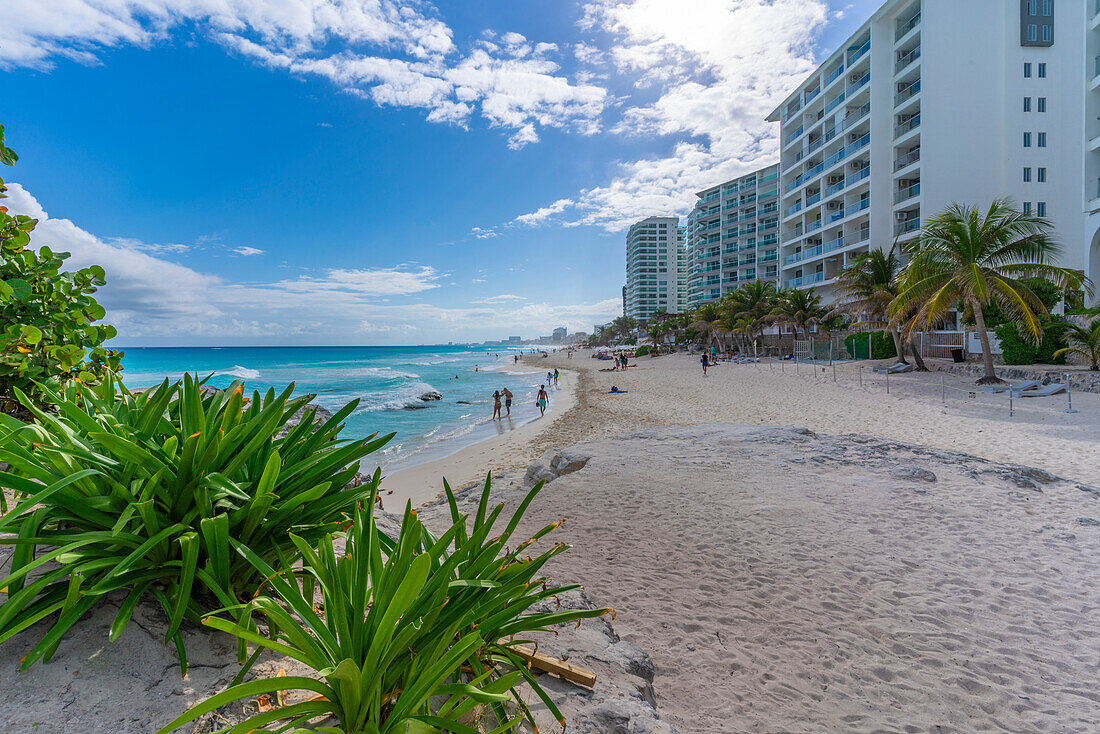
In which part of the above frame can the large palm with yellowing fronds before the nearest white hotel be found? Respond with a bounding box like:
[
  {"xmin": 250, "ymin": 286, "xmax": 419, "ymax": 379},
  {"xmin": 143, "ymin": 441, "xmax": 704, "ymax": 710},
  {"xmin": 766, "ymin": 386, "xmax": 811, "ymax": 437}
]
[{"xmin": 889, "ymin": 199, "xmax": 1091, "ymax": 385}]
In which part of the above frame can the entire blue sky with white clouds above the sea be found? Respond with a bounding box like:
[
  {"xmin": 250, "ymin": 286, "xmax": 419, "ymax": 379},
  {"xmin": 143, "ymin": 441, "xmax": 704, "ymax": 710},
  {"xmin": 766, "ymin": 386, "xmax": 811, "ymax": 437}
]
[{"xmin": 0, "ymin": 0, "xmax": 879, "ymax": 346}]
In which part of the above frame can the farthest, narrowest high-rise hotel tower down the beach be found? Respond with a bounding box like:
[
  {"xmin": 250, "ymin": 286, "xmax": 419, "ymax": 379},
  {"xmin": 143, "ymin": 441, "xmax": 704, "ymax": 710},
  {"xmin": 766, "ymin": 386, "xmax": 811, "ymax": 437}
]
[{"xmin": 623, "ymin": 217, "xmax": 686, "ymax": 321}]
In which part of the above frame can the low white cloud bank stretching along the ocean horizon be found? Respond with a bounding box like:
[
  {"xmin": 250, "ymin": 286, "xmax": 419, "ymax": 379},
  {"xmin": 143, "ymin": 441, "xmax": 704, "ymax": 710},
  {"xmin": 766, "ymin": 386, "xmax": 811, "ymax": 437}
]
[{"xmin": 4, "ymin": 183, "xmax": 622, "ymax": 344}]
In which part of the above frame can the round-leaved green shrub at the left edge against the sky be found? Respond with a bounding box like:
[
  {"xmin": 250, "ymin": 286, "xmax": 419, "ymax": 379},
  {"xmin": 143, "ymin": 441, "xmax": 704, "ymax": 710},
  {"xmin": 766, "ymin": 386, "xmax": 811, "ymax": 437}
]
[{"xmin": 0, "ymin": 125, "xmax": 122, "ymax": 417}]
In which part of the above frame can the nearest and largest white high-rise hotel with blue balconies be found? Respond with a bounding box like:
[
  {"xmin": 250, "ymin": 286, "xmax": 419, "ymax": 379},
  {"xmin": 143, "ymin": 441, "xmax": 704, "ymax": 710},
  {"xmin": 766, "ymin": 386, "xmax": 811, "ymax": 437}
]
[{"xmin": 770, "ymin": 0, "xmax": 1100, "ymax": 302}]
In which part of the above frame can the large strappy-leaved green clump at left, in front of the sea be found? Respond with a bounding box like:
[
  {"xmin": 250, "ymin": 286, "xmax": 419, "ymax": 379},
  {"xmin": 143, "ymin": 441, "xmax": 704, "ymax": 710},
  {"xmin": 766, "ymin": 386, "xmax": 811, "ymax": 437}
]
[{"xmin": 0, "ymin": 373, "xmax": 391, "ymax": 670}]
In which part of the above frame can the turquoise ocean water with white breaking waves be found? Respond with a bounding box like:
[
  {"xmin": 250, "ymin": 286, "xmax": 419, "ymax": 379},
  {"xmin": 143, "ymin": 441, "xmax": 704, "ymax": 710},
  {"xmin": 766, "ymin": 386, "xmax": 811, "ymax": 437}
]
[{"xmin": 122, "ymin": 346, "xmax": 553, "ymax": 471}]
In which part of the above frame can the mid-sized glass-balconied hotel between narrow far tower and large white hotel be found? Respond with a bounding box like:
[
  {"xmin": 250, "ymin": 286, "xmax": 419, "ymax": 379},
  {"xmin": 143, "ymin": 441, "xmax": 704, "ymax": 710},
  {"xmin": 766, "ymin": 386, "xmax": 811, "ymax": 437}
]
[{"xmin": 686, "ymin": 165, "xmax": 779, "ymax": 306}]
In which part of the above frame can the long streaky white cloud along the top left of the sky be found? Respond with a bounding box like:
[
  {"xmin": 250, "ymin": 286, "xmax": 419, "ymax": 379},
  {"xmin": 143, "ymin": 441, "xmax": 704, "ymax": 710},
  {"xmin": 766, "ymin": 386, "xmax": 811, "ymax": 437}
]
[{"xmin": 0, "ymin": 0, "xmax": 608, "ymax": 147}]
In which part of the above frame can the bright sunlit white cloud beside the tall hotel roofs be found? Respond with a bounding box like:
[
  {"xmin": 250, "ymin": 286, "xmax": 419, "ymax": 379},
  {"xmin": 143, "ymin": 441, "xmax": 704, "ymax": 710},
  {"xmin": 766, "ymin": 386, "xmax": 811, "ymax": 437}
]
[{"xmin": 518, "ymin": 0, "xmax": 828, "ymax": 231}]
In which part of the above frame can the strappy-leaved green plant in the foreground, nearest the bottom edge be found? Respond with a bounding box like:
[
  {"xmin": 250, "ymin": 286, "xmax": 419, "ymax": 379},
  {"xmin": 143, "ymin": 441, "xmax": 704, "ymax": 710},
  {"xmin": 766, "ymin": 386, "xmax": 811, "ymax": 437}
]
[{"xmin": 157, "ymin": 480, "xmax": 607, "ymax": 734}]
